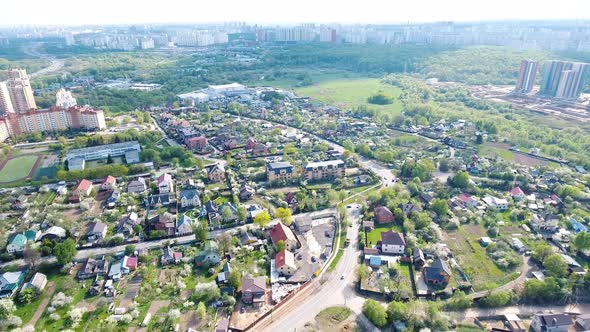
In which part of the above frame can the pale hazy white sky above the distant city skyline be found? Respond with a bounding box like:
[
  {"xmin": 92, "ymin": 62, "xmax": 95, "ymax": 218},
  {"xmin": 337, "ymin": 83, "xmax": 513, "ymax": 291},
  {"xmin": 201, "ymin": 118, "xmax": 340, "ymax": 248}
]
[{"xmin": 0, "ymin": 0, "xmax": 590, "ymax": 25}]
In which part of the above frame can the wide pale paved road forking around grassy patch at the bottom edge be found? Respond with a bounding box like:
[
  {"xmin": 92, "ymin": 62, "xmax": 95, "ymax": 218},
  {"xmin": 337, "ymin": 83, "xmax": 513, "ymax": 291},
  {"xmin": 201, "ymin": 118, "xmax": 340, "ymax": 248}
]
[{"xmin": 260, "ymin": 204, "xmax": 374, "ymax": 332}]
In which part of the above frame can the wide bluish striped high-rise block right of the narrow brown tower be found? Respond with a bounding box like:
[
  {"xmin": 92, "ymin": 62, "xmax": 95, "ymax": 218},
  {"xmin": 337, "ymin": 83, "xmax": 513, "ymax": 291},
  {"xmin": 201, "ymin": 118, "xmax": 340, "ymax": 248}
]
[{"xmin": 539, "ymin": 61, "xmax": 590, "ymax": 99}]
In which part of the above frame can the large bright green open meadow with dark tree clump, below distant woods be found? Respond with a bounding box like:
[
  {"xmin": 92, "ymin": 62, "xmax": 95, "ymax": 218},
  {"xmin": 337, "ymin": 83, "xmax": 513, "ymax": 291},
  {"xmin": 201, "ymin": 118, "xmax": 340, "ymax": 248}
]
[{"xmin": 295, "ymin": 78, "xmax": 402, "ymax": 113}]
